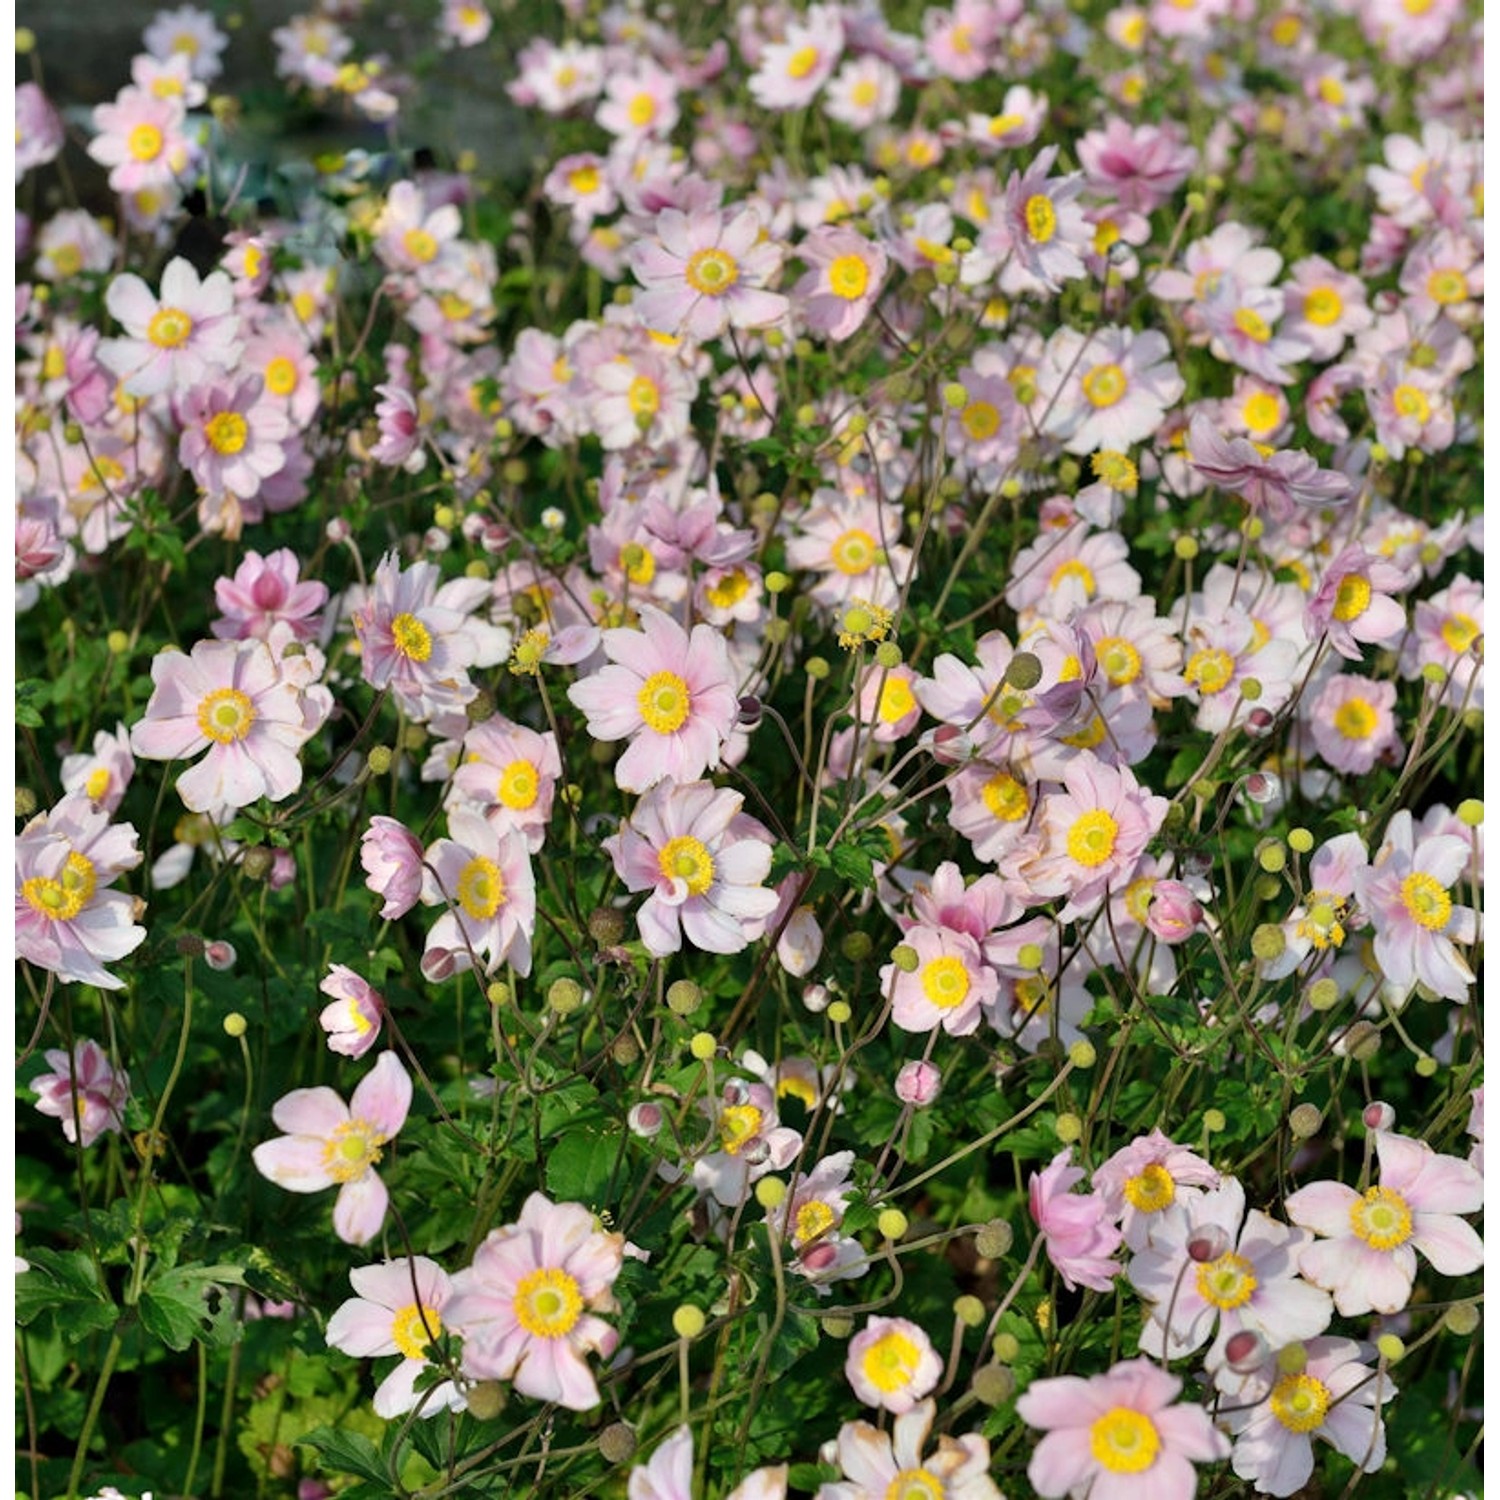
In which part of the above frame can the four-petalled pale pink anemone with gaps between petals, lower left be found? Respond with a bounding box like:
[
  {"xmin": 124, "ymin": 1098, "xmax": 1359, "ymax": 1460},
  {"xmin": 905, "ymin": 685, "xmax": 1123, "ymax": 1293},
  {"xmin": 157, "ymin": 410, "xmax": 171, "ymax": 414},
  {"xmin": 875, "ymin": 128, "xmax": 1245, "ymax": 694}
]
[{"xmin": 252, "ymin": 1052, "xmax": 411, "ymax": 1245}]
